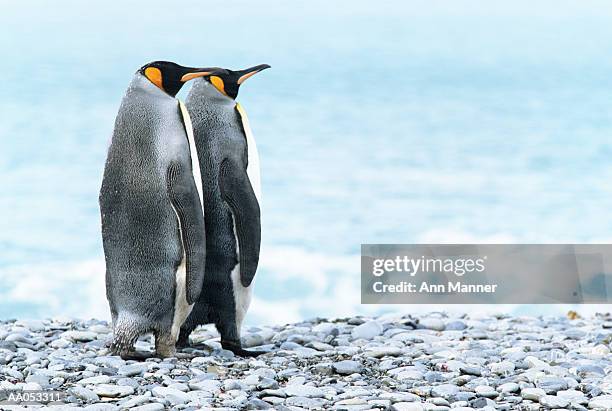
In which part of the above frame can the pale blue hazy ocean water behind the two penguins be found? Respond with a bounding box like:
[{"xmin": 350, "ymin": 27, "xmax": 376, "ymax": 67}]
[{"xmin": 0, "ymin": 0, "xmax": 612, "ymax": 323}]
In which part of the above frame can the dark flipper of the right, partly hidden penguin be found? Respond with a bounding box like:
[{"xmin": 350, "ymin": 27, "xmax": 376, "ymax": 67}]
[{"xmin": 219, "ymin": 158, "xmax": 261, "ymax": 287}]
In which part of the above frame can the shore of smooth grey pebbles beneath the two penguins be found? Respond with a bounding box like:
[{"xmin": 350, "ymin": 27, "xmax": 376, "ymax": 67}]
[{"xmin": 0, "ymin": 313, "xmax": 612, "ymax": 411}]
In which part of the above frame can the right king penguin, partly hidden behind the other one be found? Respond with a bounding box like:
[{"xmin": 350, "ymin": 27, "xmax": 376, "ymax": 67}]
[{"xmin": 178, "ymin": 64, "xmax": 270, "ymax": 356}]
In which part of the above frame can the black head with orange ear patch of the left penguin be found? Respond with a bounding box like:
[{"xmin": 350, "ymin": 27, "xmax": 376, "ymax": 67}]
[{"xmin": 138, "ymin": 61, "xmax": 219, "ymax": 97}]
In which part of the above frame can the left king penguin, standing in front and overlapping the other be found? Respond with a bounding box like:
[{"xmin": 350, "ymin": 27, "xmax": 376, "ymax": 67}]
[{"xmin": 100, "ymin": 61, "xmax": 209, "ymax": 358}]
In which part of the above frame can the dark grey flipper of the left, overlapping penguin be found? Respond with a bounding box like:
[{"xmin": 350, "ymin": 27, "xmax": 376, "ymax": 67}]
[{"xmin": 166, "ymin": 163, "xmax": 206, "ymax": 304}]
